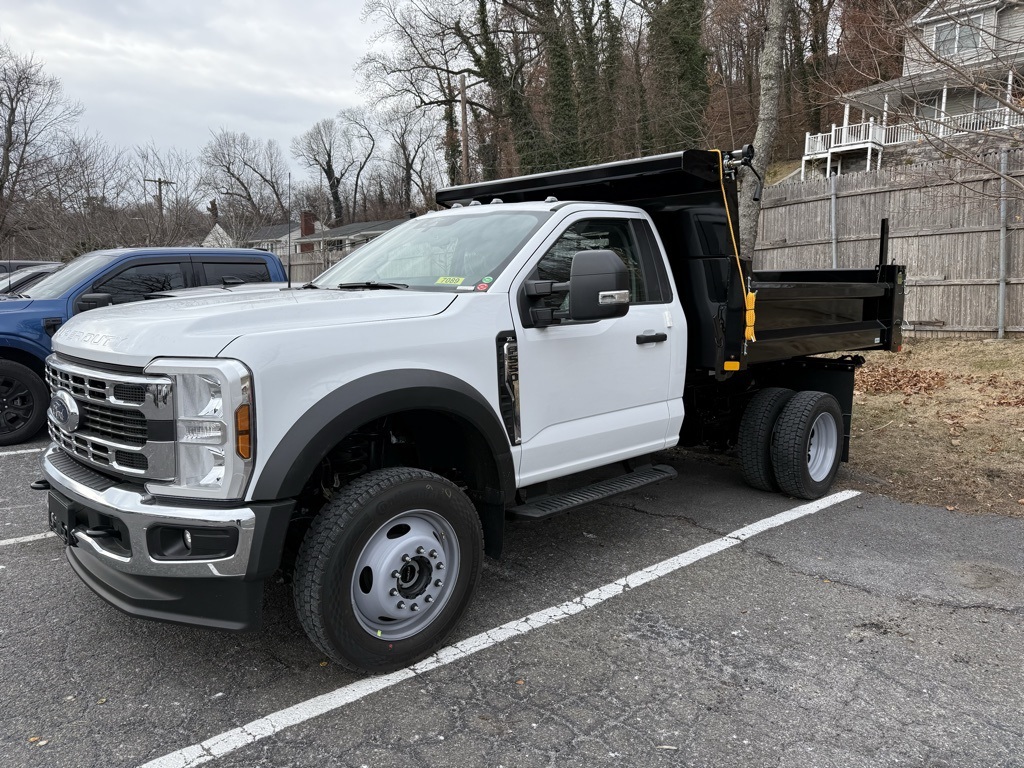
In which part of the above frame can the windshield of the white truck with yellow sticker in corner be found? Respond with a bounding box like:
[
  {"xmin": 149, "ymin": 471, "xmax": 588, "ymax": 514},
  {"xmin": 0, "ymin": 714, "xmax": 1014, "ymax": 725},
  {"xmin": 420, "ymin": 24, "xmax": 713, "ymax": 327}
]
[{"xmin": 313, "ymin": 211, "xmax": 551, "ymax": 291}]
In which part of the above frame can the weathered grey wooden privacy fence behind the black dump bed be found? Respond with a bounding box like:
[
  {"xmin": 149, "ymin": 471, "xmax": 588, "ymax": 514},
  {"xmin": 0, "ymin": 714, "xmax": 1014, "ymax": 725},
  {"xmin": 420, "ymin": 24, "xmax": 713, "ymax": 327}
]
[{"xmin": 754, "ymin": 150, "xmax": 1024, "ymax": 338}]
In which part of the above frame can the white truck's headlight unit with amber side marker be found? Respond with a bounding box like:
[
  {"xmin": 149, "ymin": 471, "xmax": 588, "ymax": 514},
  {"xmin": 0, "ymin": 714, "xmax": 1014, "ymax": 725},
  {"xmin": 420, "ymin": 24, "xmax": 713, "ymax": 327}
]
[{"xmin": 145, "ymin": 357, "xmax": 256, "ymax": 499}]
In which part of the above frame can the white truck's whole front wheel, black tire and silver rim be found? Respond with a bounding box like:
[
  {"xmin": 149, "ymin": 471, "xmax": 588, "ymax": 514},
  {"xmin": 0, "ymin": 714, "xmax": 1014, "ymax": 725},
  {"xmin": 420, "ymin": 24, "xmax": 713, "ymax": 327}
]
[{"xmin": 294, "ymin": 467, "xmax": 483, "ymax": 673}]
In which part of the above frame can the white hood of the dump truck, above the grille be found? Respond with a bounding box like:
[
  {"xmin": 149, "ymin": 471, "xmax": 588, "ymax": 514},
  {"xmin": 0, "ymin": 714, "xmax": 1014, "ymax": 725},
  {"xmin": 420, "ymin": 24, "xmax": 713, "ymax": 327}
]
[{"xmin": 53, "ymin": 289, "xmax": 456, "ymax": 368}]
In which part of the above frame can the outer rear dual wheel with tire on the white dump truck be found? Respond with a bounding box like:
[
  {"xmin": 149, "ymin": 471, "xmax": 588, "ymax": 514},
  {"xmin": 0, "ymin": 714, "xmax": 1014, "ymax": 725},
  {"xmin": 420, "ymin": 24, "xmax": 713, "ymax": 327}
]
[{"xmin": 771, "ymin": 392, "xmax": 843, "ymax": 499}]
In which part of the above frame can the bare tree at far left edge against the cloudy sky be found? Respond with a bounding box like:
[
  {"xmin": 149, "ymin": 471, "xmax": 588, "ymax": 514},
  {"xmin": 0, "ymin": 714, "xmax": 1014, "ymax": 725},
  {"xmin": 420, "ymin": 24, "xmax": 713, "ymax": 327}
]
[{"xmin": 0, "ymin": 43, "xmax": 82, "ymax": 246}]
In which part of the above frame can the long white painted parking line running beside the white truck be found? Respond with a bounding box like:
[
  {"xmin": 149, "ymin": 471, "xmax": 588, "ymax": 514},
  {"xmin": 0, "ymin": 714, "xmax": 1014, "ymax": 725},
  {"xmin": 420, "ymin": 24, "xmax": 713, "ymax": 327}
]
[{"xmin": 140, "ymin": 490, "xmax": 860, "ymax": 768}]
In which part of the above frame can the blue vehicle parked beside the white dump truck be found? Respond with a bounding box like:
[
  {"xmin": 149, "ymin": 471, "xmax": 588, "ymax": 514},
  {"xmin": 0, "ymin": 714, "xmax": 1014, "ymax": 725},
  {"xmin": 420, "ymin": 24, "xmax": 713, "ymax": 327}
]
[{"xmin": 0, "ymin": 248, "xmax": 288, "ymax": 445}]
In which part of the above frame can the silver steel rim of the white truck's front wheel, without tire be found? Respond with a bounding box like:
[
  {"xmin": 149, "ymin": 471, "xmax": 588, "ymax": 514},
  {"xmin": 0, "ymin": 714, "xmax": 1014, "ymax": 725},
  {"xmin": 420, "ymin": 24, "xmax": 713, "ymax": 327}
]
[{"xmin": 350, "ymin": 509, "xmax": 460, "ymax": 640}]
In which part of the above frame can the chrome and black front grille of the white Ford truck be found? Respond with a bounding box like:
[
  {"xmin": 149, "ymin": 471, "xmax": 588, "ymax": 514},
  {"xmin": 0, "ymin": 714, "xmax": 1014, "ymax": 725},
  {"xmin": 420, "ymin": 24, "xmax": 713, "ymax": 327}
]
[{"xmin": 46, "ymin": 354, "xmax": 175, "ymax": 480}]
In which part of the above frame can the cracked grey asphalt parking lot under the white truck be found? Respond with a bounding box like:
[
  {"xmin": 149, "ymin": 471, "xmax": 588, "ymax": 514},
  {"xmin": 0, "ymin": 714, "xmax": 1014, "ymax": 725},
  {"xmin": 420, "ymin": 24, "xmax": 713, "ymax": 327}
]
[{"xmin": 0, "ymin": 439, "xmax": 1024, "ymax": 768}]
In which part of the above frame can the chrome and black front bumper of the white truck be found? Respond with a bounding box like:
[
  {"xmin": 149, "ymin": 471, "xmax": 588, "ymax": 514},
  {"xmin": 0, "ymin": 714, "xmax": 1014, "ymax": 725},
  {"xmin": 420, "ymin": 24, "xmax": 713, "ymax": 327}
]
[{"xmin": 42, "ymin": 445, "xmax": 294, "ymax": 630}]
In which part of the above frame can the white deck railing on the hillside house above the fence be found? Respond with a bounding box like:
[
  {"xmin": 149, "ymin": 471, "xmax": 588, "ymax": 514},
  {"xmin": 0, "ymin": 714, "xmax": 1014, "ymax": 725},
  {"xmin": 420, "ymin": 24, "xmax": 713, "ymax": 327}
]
[{"xmin": 804, "ymin": 106, "xmax": 1024, "ymax": 156}]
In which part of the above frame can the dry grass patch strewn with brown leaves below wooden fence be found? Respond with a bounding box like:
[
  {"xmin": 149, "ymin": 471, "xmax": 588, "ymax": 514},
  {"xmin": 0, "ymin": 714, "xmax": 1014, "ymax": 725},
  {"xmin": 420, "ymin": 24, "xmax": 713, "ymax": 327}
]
[{"xmin": 840, "ymin": 340, "xmax": 1024, "ymax": 516}]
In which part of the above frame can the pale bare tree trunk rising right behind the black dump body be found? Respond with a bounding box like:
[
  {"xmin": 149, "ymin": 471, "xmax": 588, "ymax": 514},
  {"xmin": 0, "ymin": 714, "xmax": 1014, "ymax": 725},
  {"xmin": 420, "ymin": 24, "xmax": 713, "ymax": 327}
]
[{"xmin": 739, "ymin": 0, "xmax": 790, "ymax": 259}]
